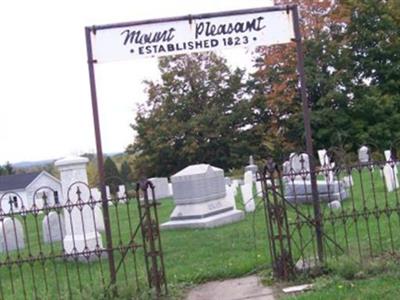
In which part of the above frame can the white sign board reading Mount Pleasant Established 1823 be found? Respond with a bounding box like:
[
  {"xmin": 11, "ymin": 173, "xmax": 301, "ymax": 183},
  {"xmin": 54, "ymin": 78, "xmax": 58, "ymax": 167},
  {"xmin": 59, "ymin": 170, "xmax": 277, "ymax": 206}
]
[{"xmin": 92, "ymin": 11, "xmax": 294, "ymax": 63}]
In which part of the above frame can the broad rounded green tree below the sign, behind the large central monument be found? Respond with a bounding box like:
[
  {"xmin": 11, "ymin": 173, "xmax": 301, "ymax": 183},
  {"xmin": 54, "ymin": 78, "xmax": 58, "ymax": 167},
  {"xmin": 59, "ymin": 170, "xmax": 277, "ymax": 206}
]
[{"xmin": 128, "ymin": 53, "xmax": 251, "ymax": 176}]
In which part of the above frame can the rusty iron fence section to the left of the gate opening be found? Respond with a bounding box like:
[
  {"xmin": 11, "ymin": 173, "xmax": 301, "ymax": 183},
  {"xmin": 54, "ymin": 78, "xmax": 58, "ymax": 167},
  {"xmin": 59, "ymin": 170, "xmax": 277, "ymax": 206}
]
[{"xmin": 0, "ymin": 180, "xmax": 167, "ymax": 299}]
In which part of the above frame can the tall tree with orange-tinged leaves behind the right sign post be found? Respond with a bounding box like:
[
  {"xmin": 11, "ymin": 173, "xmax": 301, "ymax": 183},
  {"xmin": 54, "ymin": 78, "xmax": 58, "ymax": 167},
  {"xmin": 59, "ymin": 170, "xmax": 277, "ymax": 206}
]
[{"xmin": 252, "ymin": 0, "xmax": 400, "ymax": 156}]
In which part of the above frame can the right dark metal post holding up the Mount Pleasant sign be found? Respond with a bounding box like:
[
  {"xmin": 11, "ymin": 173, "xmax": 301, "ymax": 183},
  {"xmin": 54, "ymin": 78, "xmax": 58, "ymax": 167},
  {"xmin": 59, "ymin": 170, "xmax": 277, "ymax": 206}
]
[{"xmin": 292, "ymin": 5, "xmax": 324, "ymax": 263}]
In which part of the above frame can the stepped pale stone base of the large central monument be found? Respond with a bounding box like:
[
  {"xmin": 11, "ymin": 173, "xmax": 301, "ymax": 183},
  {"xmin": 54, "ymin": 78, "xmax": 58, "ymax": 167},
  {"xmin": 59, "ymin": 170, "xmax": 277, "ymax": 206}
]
[{"xmin": 160, "ymin": 197, "xmax": 244, "ymax": 229}]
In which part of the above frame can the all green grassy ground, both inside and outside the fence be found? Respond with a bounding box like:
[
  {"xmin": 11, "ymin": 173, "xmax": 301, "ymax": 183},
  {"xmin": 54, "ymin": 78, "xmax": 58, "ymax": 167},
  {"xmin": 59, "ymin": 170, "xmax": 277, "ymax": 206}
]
[{"xmin": 0, "ymin": 166, "xmax": 400, "ymax": 299}]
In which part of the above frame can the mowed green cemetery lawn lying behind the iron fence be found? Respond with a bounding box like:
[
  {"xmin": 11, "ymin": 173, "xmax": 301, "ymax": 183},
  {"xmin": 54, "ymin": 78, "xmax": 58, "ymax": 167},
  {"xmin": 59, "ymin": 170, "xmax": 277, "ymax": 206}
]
[{"xmin": 0, "ymin": 165, "xmax": 400, "ymax": 299}]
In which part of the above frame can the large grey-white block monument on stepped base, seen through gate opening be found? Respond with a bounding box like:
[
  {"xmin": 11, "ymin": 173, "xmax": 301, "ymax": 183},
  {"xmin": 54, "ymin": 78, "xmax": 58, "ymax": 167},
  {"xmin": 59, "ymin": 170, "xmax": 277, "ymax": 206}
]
[{"xmin": 161, "ymin": 164, "xmax": 244, "ymax": 229}]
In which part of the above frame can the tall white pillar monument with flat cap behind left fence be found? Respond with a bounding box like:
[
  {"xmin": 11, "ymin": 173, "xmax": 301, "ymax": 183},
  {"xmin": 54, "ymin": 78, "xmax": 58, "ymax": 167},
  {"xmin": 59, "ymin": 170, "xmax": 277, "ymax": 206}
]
[{"xmin": 55, "ymin": 157, "xmax": 103, "ymax": 254}]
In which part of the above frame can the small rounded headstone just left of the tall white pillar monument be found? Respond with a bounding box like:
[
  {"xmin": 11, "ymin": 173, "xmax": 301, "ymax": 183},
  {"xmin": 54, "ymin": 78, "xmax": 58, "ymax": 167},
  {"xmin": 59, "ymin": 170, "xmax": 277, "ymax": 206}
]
[{"xmin": 42, "ymin": 211, "xmax": 65, "ymax": 243}]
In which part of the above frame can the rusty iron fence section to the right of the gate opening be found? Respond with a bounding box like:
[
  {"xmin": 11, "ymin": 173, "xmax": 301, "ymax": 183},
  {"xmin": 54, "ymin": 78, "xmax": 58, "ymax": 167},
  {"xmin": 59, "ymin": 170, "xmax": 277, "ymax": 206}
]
[{"xmin": 259, "ymin": 154, "xmax": 400, "ymax": 279}]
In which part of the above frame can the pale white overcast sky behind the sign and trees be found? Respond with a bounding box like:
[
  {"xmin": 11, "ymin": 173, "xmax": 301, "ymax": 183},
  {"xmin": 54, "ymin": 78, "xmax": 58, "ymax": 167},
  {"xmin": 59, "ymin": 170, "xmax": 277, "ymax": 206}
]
[{"xmin": 0, "ymin": 0, "xmax": 272, "ymax": 165}]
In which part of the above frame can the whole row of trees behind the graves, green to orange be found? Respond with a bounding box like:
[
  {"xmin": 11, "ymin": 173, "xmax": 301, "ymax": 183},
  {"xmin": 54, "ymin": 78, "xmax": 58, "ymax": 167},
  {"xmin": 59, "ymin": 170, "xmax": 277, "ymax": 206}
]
[{"xmin": 127, "ymin": 0, "xmax": 400, "ymax": 176}]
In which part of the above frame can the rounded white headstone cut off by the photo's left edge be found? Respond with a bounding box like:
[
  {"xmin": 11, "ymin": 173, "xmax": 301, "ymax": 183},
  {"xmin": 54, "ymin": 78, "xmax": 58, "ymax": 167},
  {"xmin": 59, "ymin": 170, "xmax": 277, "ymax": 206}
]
[{"xmin": 0, "ymin": 217, "xmax": 25, "ymax": 252}]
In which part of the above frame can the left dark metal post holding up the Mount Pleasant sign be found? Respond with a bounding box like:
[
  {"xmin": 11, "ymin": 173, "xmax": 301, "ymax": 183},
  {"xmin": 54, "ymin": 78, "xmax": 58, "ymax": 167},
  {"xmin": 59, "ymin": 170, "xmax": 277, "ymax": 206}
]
[{"xmin": 85, "ymin": 27, "xmax": 116, "ymax": 285}]
